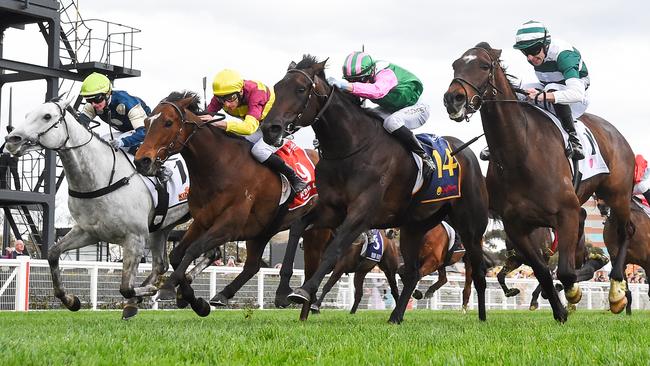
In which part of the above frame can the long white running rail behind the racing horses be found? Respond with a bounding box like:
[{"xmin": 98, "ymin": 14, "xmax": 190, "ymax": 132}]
[{"xmin": 0, "ymin": 256, "xmax": 650, "ymax": 311}]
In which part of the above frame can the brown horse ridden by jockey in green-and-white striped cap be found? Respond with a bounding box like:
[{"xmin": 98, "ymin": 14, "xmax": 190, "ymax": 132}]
[{"xmin": 443, "ymin": 42, "xmax": 634, "ymax": 322}]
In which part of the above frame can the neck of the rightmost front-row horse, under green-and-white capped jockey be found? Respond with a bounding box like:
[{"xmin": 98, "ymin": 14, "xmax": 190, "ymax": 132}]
[{"xmin": 481, "ymin": 68, "xmax": 530, "ymax": 163}]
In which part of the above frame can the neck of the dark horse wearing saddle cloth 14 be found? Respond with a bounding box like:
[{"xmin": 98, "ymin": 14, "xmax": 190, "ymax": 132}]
[{"xmin": 312, "ymin": 91, "xmax": 379, "ymax": 156}]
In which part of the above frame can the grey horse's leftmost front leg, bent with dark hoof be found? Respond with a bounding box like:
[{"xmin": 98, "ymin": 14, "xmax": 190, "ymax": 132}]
[{"xmin": 47, "ymin": 229, "xmax": 99, "ymax": 311}]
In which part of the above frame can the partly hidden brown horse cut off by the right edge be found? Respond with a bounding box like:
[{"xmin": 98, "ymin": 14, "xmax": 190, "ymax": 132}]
[{"xmin": 599, "ymin": 198, "xmax": 650, "ymax": 314}]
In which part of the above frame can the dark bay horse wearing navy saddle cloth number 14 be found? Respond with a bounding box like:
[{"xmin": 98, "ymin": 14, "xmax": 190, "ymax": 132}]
[{"xmin": 262, "ymin": 55, "xmax": 487, "ymax": 323}]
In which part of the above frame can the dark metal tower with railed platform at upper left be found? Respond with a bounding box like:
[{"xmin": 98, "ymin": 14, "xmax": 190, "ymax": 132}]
[{"xmin": 0, "ymin": 0, "xmax": 140, "ymax": 258}]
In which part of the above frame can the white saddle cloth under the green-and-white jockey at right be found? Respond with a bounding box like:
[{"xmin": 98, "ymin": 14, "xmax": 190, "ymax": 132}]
[{"xmin": 535, "ymin": 106, "xmax": 609, "ymax": 181}]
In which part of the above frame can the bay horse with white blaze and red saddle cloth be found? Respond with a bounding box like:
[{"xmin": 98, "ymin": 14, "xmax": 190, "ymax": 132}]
[{"xmin": 135, "ymin": 91, "xmax": 330, "ymax": 316}]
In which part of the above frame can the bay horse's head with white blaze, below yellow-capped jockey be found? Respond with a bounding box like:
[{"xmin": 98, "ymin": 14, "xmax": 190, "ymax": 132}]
[{"xmin": 135, "ymin": 91, "xmax": 202, "ymax": 175}]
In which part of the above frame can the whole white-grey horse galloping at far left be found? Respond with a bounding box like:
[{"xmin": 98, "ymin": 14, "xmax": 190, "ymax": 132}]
[{"xmin": 5, "ymin": 97, "xmax": 189, "ymax": 319}]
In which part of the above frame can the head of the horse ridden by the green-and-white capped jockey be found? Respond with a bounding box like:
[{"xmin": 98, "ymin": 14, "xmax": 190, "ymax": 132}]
[{"xmin": 443, "ymin": 42, "xmax": 501, "ymax": 122}]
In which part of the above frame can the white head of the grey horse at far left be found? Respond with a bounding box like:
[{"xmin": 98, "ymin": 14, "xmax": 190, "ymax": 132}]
[{"xmin": 5, "ymin": 95, "xmax": 77, "ymax": 156}]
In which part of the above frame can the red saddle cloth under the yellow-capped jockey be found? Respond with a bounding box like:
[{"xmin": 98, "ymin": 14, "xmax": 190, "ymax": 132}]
[{"xmin": 276, "ymin": 140, "xmax": 318, "ymax": 210}]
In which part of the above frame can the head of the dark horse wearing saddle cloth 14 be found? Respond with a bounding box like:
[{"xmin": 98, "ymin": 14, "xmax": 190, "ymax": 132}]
[{"xmin": 262, "ymin": 55, "xmax": 332, "ymax": 146}]
